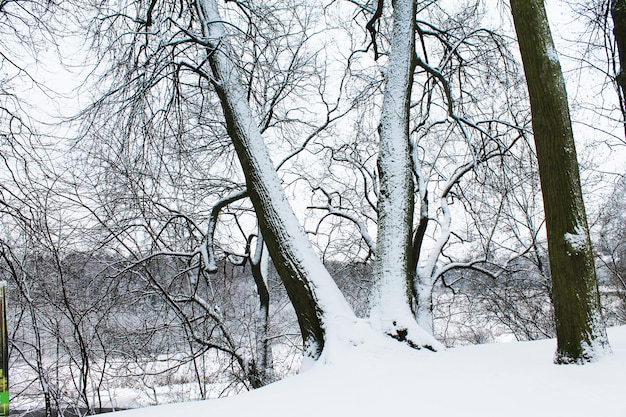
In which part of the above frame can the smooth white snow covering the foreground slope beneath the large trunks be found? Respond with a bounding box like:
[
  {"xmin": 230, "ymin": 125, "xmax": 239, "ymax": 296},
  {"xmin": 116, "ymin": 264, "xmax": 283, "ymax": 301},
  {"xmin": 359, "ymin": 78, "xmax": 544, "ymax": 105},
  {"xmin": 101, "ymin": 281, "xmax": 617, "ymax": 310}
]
[{"xmin": 100, "ymin": 327, "xmax": 626, "ymax": 417}]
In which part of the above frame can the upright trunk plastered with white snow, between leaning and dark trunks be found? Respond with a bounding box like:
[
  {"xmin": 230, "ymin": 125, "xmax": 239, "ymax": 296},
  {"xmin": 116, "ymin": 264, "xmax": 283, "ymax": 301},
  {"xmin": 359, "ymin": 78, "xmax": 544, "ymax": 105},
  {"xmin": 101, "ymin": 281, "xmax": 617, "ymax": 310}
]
[{"xmin": 370, "ymin": 0, "xmax": 439, "ymax": 349}]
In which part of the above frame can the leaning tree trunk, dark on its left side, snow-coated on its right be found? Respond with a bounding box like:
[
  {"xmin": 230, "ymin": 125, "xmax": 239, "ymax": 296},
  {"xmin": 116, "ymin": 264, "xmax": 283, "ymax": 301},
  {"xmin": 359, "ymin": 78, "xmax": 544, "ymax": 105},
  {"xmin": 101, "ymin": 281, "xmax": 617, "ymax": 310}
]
[{"xmin": 200, "ymin": 0, "xmax": 356, "ymax": 359}]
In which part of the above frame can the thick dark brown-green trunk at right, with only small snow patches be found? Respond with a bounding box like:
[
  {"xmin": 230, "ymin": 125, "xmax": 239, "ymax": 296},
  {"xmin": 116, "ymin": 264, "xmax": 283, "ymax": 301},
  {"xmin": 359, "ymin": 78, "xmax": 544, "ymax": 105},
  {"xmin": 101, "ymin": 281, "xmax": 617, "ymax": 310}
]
[{"xmin": 511, "ymin": 0, "xmax": 609, "ymax": 363}]
